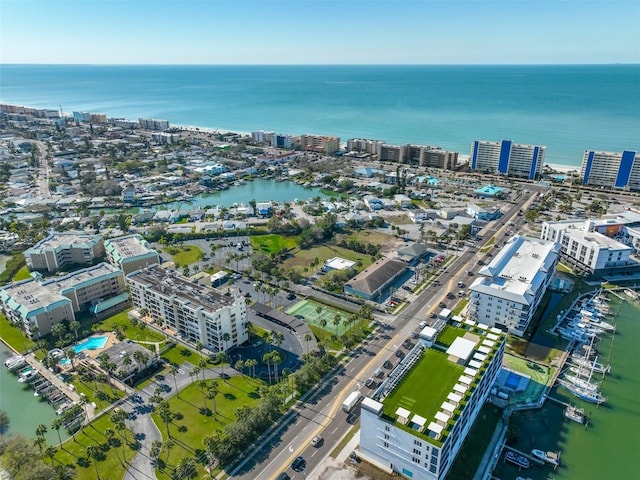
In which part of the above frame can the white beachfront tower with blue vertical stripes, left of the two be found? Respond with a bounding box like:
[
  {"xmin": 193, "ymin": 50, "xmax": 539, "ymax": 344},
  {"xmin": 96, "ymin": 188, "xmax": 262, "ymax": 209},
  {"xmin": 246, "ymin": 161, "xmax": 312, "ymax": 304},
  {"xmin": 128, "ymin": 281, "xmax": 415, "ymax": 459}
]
[{"xmin": 471, "ymin": 140, "xmax": 547, "ymax": 180}]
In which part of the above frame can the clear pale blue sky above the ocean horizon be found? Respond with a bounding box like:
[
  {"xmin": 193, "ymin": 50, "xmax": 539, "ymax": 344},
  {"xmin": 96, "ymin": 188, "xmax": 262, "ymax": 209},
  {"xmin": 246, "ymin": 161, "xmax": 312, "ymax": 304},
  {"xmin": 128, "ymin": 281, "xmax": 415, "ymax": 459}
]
[{"xmin": 0, "ymin": 0, "xmax": 640, "ymax": 64}]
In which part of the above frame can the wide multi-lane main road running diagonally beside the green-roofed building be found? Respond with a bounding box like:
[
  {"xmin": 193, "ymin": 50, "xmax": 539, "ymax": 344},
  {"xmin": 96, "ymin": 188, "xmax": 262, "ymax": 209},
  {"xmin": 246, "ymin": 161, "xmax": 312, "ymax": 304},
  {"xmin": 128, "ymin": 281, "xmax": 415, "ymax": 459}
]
[{"xmin": 225, "ymin": 185, "xmax": 534, "ymax": 480}]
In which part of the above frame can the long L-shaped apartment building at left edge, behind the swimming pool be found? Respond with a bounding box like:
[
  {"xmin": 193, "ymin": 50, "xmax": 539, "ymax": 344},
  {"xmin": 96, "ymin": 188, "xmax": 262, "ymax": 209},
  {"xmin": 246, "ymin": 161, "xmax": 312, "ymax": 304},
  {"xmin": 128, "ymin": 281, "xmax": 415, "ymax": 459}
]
[{"xmin": 0, "ymin": 263, "xmax": 128, "ymax": 337}]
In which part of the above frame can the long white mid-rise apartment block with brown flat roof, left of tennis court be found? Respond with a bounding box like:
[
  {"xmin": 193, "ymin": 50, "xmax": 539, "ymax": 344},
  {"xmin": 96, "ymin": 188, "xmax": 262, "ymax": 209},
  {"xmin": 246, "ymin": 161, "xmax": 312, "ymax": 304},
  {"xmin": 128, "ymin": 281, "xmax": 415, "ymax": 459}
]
[{"xmin": 127, "ymin": 265, "xmax": 249, "ymax": 353}]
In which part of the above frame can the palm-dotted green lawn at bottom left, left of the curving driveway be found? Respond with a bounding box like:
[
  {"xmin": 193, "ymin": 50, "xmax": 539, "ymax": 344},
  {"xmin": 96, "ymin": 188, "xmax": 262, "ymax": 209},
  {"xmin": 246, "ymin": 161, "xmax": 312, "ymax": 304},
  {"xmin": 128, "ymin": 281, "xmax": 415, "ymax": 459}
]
[{"xmin": 54, "ymin": 415, "xmax": 136, "ymax": 480}]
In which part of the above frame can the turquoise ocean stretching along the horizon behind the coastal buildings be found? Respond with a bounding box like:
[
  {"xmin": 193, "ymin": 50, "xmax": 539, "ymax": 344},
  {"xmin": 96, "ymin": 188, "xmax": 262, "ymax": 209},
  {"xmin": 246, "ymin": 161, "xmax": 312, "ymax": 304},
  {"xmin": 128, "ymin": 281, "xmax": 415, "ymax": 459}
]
[{"xmin": 0, "ymin": 65, "xmax": 640, "ymax": 167}]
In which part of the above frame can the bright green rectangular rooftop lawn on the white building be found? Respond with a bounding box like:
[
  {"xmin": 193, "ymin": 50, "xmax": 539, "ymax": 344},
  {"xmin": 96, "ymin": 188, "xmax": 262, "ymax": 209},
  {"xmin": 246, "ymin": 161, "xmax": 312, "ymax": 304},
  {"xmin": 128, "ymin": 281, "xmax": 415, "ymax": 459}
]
[{"xmin": 384, "ymin": 349, "xmax": 464, "ymax": 421}]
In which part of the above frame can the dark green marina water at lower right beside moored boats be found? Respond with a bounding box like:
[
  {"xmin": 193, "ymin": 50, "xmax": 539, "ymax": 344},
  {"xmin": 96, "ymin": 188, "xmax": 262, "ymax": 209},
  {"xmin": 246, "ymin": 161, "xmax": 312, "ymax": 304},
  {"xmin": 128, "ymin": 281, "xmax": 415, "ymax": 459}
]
[{"xmin": 494, "ymin": 299, "xmax": 640, "ymax": 480}]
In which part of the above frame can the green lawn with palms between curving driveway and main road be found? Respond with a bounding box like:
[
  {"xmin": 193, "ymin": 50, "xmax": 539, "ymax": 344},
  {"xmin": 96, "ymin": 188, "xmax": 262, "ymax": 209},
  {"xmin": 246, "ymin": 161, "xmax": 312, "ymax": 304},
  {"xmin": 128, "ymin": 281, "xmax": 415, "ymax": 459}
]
[{"xmin": 152, "ymin": 376, "xmax": 264, "ymax": 480}]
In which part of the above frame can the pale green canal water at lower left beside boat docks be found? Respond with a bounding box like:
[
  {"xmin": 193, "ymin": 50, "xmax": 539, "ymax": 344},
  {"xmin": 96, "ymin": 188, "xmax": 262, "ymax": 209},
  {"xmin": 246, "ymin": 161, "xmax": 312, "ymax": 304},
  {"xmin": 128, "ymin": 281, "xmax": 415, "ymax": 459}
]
[{"xmin": 0, "ymin": 342, "xmax": 69, "ymax": 445}]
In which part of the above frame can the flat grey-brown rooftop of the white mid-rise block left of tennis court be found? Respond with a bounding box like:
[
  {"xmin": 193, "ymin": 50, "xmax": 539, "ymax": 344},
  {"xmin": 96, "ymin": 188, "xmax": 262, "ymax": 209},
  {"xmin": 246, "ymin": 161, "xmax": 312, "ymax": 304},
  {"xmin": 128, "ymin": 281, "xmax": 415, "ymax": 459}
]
[{"xmin": 127, "ymin": 265, "xmax": 235, "ymax": 311}]
